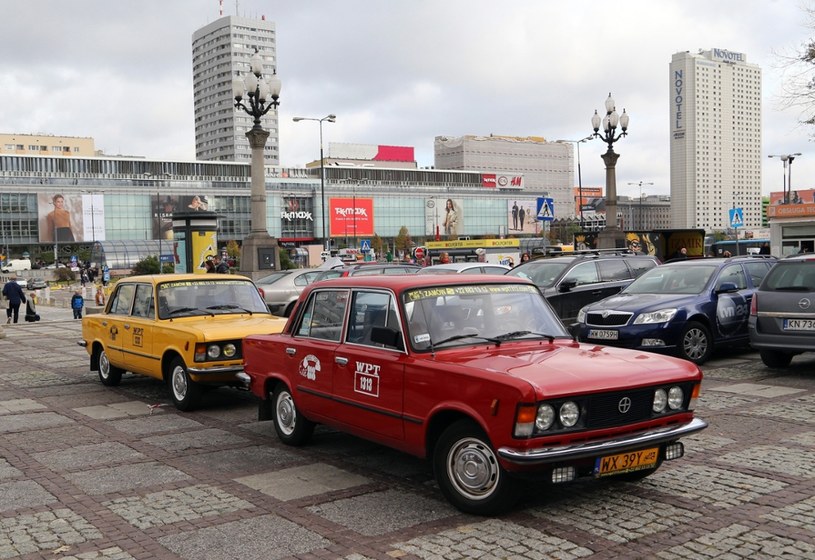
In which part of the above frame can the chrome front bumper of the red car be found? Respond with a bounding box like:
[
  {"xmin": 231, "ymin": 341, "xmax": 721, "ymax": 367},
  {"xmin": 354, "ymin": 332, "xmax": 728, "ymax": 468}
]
[{"xmin": 498, "ymin": 418, "xmax": 707, "ymax": 465}]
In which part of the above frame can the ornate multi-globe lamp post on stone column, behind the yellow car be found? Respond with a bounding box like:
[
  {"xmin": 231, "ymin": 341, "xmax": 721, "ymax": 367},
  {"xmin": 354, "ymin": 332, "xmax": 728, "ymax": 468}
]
[{"xmin": 232, "ymin": 48, "xmax": 281, "ymax": 278}]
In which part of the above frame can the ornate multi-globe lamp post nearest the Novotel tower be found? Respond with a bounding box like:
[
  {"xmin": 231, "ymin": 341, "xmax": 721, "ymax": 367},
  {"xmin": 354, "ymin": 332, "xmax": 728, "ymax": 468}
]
[{"xmin": 591, "ymin": 93, "xmax": 628, "ymax": 249}]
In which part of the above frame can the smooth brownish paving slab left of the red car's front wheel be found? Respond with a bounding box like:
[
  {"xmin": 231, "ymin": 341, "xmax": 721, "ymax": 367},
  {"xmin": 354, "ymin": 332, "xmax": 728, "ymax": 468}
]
[{"xmin": 235, "ymin": 463, "xmax": 370, "ymax": 501}]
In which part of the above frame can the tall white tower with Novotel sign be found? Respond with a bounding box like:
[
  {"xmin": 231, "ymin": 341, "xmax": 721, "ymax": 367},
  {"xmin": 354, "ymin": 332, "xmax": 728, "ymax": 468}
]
[{"xmin": 670, "ymin": 49, "xmax": 761, "ymax": 231}]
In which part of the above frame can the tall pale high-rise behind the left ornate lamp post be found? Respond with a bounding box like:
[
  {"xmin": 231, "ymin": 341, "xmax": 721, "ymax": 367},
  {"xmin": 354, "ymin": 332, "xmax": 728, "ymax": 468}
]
[{"xmin": 192, "ymin": 16, "xmax": 280, "ymax": 165}]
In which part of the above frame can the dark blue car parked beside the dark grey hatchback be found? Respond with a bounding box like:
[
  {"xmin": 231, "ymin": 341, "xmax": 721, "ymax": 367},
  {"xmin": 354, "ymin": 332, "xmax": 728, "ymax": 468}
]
[{"xmin": 573, "ymin": 256, "xmax": 776, "ymax": 364}]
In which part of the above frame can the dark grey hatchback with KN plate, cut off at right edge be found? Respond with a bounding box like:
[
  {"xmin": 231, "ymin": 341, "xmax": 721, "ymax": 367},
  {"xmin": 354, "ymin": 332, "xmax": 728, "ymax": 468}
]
[{"xmin": 748, "ymin": 254, "xmax": 815, "ymax": 368}]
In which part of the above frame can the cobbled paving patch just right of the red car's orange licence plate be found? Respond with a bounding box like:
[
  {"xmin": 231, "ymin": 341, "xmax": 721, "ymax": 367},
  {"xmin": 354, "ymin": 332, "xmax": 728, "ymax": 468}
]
[{"xmin": 640, "ymin": 464, "xmax": 787, "ymax": 507}]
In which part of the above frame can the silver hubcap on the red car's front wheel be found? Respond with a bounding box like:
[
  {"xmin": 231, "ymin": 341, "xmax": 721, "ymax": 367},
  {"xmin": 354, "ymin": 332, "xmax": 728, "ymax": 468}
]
[{"xmin": 447, "ymin": 438, "xmax": 499, "ymax": 500}]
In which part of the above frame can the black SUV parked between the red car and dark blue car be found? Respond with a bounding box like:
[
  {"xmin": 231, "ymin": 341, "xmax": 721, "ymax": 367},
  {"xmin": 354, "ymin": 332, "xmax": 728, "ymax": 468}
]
[{"xmin": 507, "ymin": 250, "xmax": 659, "ymax": 327}]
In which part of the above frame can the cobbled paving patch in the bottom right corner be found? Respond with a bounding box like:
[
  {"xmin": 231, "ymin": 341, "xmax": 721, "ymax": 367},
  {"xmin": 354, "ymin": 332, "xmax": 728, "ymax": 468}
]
[{"xmin": 656, "ymin": 524, "xmax": 815, "ymax": 560}]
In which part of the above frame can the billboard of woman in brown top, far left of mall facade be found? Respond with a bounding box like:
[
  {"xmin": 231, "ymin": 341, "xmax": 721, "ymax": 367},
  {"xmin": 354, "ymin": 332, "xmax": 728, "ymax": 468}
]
[{"xmin": 37, "ymin": 193, "xmax": 105, "ymax": 243}]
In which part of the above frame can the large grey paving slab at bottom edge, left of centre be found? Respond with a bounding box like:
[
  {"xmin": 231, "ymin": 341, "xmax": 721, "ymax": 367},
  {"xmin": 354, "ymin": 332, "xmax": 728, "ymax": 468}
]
[{"xmin": 158, "ymin": 515, "xmax": 331, "ymax": 560}]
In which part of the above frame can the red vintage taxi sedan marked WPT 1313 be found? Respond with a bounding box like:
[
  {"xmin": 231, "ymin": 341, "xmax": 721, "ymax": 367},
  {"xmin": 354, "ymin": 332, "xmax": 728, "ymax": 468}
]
[{"xmin": 244, "ymin": 275, "xmax": 707, "ymax": 515}]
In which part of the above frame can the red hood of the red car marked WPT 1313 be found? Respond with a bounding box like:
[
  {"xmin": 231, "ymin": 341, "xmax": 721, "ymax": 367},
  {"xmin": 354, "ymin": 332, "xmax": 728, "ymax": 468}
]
[{"xmin": 437, "ymin": 343, "xmax": 701, "ymax": 398}]
